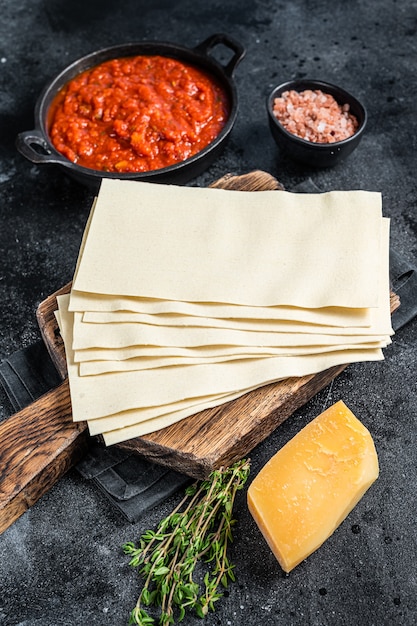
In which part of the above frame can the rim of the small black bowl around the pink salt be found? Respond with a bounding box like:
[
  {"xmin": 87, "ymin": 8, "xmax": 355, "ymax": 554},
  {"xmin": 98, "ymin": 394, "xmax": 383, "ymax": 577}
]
[{"xmin": 267, "ymin": 78, "xmax": 368, "ymax": 151}]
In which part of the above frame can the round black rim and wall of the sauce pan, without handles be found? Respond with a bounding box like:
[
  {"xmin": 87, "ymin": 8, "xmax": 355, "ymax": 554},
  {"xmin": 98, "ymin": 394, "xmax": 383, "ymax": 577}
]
[{"xmin": 34, "ymin": 36, "xmax": 240, "ymax": 180}]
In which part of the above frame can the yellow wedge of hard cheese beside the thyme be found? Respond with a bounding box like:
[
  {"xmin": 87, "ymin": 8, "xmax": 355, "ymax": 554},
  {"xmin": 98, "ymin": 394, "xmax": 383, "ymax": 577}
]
[{"xmin": 248, "ymin": 401, "xmax": 379, "ymax": 572}]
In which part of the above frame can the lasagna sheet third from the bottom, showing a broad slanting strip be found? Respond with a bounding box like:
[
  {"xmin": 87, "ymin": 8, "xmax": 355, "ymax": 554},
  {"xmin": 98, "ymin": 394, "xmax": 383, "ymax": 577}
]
[{"xmin": 58, "ymin": 296, "xmax": 383, "ymax": 426}]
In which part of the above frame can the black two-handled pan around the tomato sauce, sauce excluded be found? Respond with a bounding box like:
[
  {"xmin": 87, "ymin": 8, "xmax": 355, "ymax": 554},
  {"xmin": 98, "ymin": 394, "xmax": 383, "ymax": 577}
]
[{"xmin": 16, "ymin": 34, "xmax": 245, "ymax": 188}]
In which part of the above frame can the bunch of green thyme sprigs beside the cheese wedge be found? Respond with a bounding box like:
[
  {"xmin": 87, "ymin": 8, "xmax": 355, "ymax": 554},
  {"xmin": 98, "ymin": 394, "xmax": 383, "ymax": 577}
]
[{"xmin": 123, "ymin": 459, "xmax": 250, "ymax": 626}]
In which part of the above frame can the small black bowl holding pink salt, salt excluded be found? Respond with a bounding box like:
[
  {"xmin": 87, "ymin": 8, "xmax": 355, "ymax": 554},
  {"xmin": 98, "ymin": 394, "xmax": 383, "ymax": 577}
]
[{"xmin": 267, "ymin": 79, "xmax": 367, "ymax": 167}]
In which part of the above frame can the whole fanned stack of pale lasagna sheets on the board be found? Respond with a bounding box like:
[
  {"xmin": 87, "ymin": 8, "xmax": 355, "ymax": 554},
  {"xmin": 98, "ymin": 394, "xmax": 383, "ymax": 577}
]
[{"xmin": 56, "ymin": 180, "xmax": 393, "ymax": 445}]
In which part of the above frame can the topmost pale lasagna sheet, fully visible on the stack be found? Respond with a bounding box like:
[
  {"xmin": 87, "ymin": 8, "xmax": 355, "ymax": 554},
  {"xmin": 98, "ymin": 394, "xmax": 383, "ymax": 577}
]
[{"xmin": 74, "ymin": 179, "xmax": 381, "ymax": 308}]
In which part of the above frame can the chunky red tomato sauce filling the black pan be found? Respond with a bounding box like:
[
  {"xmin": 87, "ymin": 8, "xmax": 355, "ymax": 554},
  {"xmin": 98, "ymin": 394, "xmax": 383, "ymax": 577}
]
[{"xmin": 49, "ymin": 55, "xmax": 229, "ymax": 172}]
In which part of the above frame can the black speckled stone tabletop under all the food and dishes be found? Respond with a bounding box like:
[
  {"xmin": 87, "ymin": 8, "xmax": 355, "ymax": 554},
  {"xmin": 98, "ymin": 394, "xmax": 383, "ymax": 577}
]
[{"xmin": 0, "ymin": 0, "xmax": 417, "ymax": 626}]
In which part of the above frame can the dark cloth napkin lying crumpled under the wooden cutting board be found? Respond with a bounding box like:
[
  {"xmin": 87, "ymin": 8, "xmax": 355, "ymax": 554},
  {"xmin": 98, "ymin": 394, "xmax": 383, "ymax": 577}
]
[{"xmin": 0, "ymin": 179, "xmax": 417, "ymax": 522}]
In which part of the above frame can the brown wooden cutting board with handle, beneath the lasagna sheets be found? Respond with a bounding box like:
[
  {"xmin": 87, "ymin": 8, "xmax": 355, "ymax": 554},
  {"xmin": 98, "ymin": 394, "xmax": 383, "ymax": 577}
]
[{"xmin": 0, "ymin": 171, "xmax": 399, "ymax": 532}]
